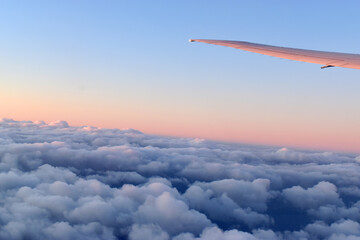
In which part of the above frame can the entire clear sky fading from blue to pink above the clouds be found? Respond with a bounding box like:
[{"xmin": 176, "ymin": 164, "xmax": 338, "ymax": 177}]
[{"xmin": 0, "ymin": 0, "xmax": 360, "ymax": 152}]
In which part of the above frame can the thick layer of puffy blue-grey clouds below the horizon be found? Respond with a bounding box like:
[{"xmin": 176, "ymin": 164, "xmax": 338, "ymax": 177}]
[{"xmin": 0, "ymin": 119, "xmax": 360, "ymax": 240}]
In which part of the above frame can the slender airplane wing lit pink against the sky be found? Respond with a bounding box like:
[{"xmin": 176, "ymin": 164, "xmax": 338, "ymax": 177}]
[{"xmin": 190, "ymin": 39, "xmax": 360, "ymax": 69}]
